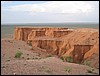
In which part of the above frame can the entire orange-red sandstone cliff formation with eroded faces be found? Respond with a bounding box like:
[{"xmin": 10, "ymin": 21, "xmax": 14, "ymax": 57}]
[{"xmin": 14, "ymin": 27, "xmax": 99, "ymax": 66}]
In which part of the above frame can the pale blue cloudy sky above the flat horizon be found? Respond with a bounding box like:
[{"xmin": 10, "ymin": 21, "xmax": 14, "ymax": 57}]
[{"xmin": 1, "ymin": 1, "xmax": 99, "ymax": 24}]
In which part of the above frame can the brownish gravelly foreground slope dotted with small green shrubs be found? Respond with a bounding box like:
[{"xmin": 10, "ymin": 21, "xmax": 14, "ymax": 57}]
[{"xmin": 1, "ymin": 38, "xmax": 99, "ymax": 75}]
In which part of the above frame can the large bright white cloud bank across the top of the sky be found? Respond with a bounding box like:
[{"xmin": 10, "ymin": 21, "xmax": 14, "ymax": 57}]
[{"xmin": 3, "ymin": 1, "xmax": 93, "ymax": 13}]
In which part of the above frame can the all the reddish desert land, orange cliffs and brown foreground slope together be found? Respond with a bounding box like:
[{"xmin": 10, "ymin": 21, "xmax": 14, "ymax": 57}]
[{"xmin": 1, "ymin": 27, "xmax": 99, "ymax": 75}]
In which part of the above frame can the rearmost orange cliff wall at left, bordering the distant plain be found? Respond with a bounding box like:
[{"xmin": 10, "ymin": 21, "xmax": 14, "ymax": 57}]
[{"xmin": 14, "ymin": 27, "xmax": 68, "ymax": 41}]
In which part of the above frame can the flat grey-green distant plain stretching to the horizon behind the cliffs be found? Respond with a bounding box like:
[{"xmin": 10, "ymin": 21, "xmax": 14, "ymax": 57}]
[{"xmin": 1, "ymin": 23, "xmax": 99, "ymax": 38}]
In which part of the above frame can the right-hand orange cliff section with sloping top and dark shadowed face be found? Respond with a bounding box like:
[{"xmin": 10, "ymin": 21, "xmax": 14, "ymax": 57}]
[{"xmin": 62, "ymin": 29, "xmax": 99, "ymax": 62}]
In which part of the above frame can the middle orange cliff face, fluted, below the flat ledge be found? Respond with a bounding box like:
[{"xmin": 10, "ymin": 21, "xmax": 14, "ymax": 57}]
[{"xmin": 30, "ymin": 37, "xmax": 71, "ymax": 56}]
